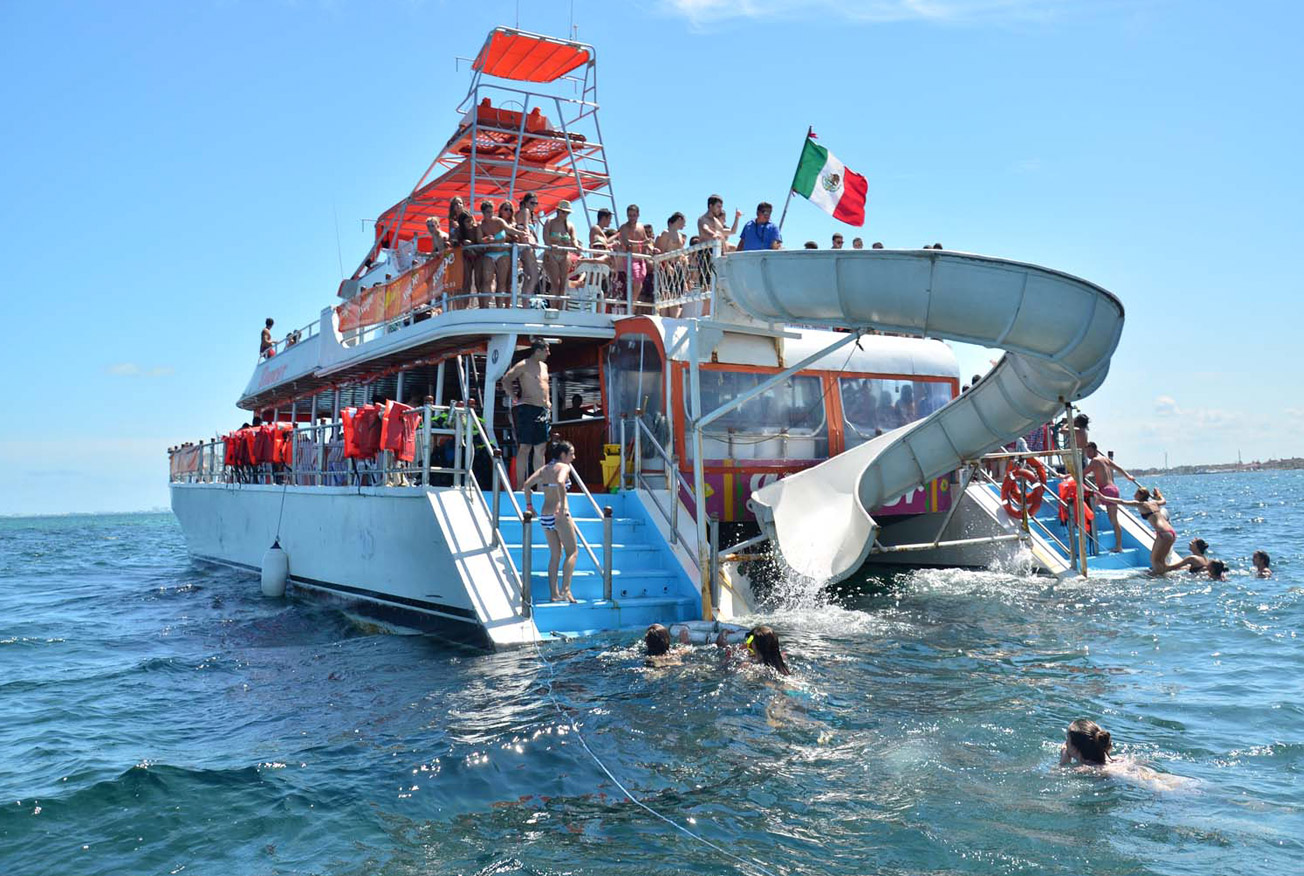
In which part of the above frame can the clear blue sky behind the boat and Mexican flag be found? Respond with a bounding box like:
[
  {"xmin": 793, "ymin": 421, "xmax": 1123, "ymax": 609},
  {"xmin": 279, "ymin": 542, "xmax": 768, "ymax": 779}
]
[{"xmin": 0, "ymin": 0, "xmax": 1304, "ymax": 514}]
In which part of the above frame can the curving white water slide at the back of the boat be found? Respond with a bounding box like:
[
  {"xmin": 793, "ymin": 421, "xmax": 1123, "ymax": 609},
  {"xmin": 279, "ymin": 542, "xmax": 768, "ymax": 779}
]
[{"xmin": 719, "ymin": 250, "xmax": 1123, "ymax": 581}]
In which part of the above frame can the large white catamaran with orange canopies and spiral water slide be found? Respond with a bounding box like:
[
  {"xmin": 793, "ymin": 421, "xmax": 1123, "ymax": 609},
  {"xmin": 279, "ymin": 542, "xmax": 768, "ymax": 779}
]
[{"xmin": 170, "ymin": 27, "xmax": 1168, "ymax": 648}]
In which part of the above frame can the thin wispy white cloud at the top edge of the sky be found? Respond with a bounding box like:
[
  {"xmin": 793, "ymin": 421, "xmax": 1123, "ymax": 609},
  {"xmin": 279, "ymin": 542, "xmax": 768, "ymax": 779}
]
[{"xmin": 661, "ymin": 0, "xmax": 1069, "ymax": 25}]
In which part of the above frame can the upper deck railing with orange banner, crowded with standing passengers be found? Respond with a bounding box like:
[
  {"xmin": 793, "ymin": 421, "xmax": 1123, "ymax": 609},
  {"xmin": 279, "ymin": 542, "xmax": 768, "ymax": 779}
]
[{"xmin": 324, "ymin": 242, "xmax": 719, "ymax": 345}]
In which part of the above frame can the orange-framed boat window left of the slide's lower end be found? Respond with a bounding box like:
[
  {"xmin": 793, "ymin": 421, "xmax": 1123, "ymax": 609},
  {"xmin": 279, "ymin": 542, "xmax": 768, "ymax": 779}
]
[{"xmin": 685, "ymin": 369, "xmax": 828, "ymax": 460}]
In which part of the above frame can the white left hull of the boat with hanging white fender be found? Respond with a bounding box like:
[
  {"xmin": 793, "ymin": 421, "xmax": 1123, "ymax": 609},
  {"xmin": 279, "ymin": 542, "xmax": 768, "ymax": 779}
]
[{"xmin": 172, "ymin": 484, "xmax": 539, "ymax": 648}]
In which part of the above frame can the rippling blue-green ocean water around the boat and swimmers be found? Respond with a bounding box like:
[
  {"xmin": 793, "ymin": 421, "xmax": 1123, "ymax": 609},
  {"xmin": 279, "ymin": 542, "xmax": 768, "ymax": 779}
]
[{"xmin": 0, "ymin": 472, "xmax": 1304, "ymax": 876}]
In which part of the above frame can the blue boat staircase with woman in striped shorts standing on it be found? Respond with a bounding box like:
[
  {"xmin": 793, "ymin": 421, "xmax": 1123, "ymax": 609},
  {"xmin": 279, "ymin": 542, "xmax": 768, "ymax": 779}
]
[{"xmin": 485, "ymin": 491, "xmax": 702, "ymax": 636}]
